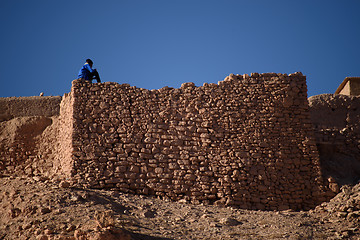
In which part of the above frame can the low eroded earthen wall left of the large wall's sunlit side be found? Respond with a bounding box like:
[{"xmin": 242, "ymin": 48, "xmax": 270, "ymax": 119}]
[{"xmin": 0, "ymin": 96, "xmax": 61, "ymax": 176}]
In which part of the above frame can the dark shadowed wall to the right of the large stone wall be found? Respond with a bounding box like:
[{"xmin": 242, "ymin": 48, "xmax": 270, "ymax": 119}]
[{"xmin": 309, "ymin": 94, "xmax": 360, "ymax": 185}]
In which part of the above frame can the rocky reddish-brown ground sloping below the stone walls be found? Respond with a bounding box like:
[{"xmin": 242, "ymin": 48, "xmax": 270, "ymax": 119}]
[{"xmin": 0, "ymin": 176, "xmax": 360, "ymax": 240}]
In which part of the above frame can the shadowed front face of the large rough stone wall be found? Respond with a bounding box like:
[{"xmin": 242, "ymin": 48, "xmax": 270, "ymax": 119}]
[{"xmin": 68, "ymin": 73, "xmax": 325, "ymax": 209}]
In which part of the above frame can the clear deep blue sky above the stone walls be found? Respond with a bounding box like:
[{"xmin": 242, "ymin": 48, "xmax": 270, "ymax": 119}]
[{"xmin": 0, "ymin": 0, "xmax": 360, "ymax": 97}]
